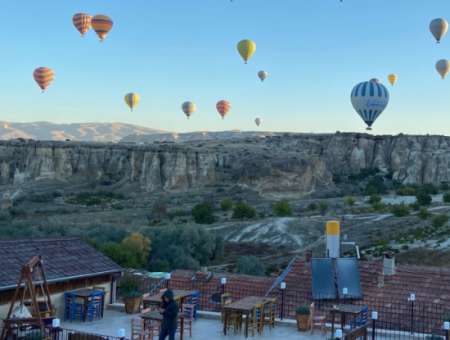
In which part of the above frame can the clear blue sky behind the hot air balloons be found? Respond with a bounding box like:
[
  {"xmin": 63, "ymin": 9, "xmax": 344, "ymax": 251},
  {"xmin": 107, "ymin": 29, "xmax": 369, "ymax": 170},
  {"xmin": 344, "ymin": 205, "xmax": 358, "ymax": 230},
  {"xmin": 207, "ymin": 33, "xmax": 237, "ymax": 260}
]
[{"xmin": 0, "ymin": 0, "xmax": 450, "ymax": 134}]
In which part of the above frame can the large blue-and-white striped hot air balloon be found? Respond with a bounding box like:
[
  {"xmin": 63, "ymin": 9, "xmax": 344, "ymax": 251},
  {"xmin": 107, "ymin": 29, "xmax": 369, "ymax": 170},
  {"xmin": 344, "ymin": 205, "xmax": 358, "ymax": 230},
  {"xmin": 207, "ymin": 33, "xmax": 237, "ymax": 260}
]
[{"xmin": 350, "ymin": 81, "xmax": 389, "ymax": 130}]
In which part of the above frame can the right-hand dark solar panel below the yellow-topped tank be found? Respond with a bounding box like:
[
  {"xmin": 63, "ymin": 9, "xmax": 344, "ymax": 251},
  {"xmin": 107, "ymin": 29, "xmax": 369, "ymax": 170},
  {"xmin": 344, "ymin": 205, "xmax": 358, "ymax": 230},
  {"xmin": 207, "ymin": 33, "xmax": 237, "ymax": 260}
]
[{"xmin": 336, "ymin": 258, "xmax": 362, "ymax": 299}]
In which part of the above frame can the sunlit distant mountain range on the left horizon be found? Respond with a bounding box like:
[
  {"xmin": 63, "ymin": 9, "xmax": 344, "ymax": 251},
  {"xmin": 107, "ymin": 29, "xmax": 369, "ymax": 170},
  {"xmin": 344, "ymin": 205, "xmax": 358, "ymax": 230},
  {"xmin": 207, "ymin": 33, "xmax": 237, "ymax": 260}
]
[{"xmin": 0, "ymin": 122, "xmax": 169, "ymax": 142}]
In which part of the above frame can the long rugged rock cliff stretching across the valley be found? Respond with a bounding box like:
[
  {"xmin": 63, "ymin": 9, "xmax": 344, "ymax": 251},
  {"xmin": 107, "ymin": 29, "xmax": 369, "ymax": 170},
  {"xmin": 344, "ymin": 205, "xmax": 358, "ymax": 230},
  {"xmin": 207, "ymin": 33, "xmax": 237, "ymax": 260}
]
[{"xmin": 0, "ymin": 132, "xmax": 450, "ymax": 196}]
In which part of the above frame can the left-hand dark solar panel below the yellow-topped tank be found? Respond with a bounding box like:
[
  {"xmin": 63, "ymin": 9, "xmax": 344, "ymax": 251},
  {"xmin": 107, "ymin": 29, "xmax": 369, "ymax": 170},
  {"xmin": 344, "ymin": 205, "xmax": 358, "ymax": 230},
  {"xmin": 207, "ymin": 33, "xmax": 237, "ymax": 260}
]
[{"xmin": 311, "ymin": 258, "xmax": 336, "ymax": 300}]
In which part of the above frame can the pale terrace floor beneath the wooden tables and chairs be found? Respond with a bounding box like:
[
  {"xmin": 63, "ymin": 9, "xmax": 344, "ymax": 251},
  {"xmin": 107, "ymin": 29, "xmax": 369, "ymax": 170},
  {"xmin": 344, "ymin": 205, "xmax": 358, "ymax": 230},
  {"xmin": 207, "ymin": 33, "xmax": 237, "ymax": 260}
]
[{"xmin": 61, "ymin": 309, "xmax": 330, "ymax": 340}]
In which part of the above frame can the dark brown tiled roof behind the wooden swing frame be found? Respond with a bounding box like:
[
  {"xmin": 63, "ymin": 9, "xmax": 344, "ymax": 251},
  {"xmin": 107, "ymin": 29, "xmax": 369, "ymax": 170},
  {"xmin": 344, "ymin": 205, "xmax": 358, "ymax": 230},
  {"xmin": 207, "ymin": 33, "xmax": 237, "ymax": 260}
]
[{"xmin": 0, "ymin": 236, "xmax": 124, "ymax": 290}]
